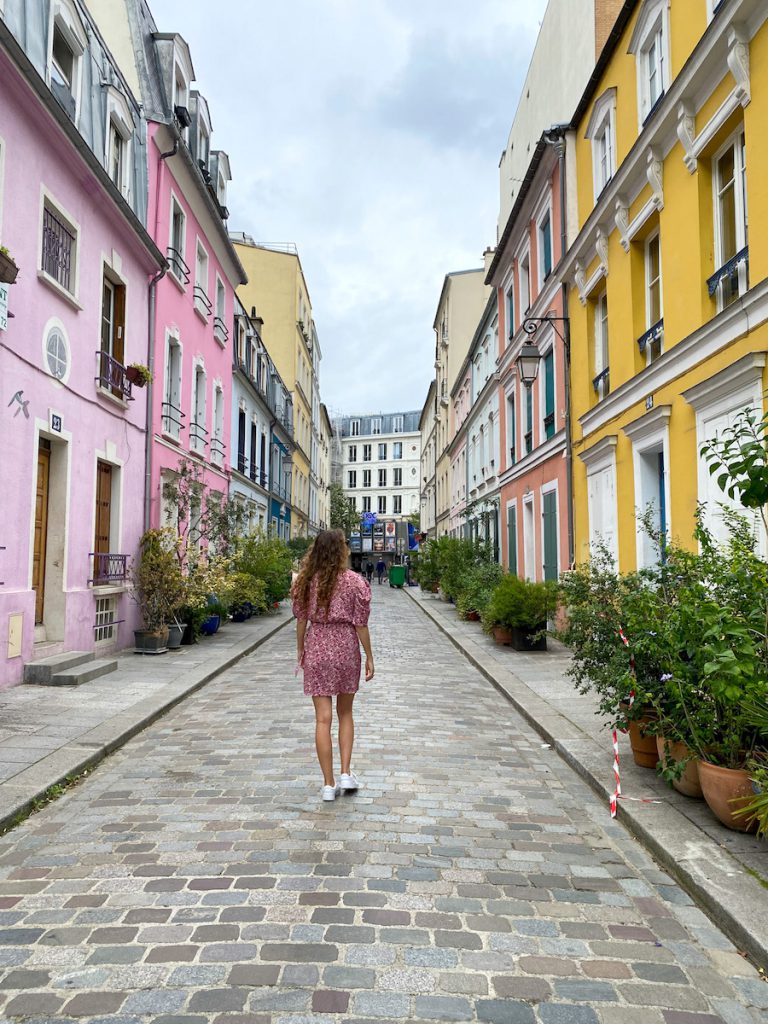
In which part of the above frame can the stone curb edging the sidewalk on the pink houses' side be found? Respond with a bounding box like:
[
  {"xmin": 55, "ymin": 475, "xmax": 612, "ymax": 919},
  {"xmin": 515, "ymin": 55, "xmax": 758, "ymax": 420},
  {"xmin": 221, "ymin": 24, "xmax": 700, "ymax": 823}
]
[{"xmin": 0, "ymin": 614, "xmax": 293, "ymax": 836}]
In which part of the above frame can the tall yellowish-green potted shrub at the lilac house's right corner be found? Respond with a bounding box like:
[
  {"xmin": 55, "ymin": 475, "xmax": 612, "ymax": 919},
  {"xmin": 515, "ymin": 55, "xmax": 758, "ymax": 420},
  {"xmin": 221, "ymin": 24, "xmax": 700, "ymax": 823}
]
[{"xmin": 131, "ymin": 529, "xmax": 183, "ymax": 654}]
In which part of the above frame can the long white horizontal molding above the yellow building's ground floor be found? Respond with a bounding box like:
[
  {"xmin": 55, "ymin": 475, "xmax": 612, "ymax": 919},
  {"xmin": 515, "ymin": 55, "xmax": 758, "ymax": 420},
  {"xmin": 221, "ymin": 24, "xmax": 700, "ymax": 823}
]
[{"xmin": 579, "ymin": 280, "xmax": 768, "ymax": 436}]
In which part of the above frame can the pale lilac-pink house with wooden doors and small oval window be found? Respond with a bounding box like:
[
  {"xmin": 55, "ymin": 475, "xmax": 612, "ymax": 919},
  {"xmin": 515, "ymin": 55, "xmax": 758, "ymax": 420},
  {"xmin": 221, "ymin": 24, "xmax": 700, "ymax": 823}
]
[{"xmin": 0, "ymin": 9, "xmax": 165, "ymax": 688}]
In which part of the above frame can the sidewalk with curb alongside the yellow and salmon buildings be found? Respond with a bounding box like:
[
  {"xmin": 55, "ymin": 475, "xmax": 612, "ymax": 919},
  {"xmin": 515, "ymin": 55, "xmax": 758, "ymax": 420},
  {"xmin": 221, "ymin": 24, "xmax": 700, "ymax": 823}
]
[{"xmin": 406, "ymin": 588, "xmax": 768, "ymax": 970}]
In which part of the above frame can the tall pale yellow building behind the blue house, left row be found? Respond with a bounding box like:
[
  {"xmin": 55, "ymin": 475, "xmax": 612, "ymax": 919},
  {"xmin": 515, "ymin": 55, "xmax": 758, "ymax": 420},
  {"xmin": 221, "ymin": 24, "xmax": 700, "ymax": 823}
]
[{"xmin": 231, "ymin": 233, "xmax": 313, "ymax": 537}]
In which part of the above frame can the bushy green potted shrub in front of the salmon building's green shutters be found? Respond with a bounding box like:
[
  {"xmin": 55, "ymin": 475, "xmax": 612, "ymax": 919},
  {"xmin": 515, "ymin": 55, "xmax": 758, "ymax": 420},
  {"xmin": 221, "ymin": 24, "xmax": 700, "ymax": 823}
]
[{"xmin": 482, "ymin": 573, "xmax": 556, "ymax": 651}]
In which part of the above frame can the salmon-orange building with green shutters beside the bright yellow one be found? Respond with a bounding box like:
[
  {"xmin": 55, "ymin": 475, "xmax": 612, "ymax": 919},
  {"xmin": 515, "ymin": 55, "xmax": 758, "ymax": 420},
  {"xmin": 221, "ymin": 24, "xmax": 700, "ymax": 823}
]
[{"xmin": 486, "ymin": 130, "xmax": 572, "ymax": 580}]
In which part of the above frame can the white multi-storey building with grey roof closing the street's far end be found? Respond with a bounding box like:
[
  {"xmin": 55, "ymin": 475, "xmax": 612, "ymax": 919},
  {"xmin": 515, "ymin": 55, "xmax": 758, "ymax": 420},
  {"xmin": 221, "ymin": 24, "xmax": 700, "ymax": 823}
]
[{"xmin": 337, "ymin": 410, "xmax": 421, "ymax": 520}]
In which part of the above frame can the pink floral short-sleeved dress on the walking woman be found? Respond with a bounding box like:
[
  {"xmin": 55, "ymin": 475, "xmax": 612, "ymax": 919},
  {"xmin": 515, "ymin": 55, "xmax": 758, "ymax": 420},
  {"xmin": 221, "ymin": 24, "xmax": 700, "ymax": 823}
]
[{"xmin": 293, "ymin": 569, "xmax": 371, "ymax": 697}]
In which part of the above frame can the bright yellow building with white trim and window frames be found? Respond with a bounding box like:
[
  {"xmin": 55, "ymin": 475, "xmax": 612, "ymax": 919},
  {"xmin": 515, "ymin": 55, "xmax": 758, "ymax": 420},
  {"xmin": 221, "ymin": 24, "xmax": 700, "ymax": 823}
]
[{"xmin": 565, "ymin": 0, "xmax": 768, "ymax": 570}]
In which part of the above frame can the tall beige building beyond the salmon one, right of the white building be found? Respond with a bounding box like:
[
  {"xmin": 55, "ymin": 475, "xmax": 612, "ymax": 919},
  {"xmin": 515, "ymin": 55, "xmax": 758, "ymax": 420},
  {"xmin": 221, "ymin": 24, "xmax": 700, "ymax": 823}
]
[{"xmin": 434, "ymin": 268, "xmax": 493, "ymax": 537}]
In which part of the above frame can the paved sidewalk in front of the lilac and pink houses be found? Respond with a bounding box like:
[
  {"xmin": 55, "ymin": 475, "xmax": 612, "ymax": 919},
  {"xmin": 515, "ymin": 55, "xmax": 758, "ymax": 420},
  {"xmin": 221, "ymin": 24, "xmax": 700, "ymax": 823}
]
[{"xmin": 0, "ymin": 604, "xmax": 292, "ymax": 833}]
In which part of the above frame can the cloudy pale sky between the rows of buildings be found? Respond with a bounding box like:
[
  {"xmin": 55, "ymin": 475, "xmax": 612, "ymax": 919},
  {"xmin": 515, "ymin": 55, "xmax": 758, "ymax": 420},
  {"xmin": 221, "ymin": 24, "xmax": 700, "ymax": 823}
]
[{"xmin": 150, "ymin": 0, "xmax": 546, "ymax": 413}]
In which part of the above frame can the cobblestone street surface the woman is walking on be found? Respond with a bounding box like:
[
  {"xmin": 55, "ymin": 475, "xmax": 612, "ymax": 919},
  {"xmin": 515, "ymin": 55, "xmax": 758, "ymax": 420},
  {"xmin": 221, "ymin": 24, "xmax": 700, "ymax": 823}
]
[{"xmin": 0, "ymin": 585, "xmax": 768, "ymax": 1024}]
